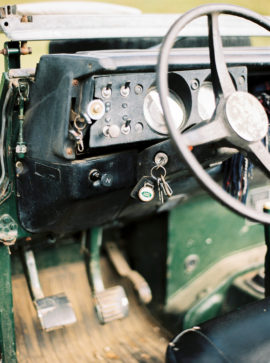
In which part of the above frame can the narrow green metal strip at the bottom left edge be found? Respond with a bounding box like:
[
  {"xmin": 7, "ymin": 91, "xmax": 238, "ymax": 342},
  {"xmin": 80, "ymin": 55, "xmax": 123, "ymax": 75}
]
[{"xmin": 0, "ymin": 244, "xmax": 17, "ymax": 363}]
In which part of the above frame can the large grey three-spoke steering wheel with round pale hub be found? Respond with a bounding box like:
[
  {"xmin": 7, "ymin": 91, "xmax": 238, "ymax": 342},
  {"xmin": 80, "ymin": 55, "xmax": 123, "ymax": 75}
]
[{"xmin": 157, "ymin": 4, "xmax": 270, "ymax": 224}]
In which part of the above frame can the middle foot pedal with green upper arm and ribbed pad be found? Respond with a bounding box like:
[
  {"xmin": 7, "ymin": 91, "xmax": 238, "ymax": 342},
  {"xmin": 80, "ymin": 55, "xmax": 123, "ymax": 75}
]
[{"xmin": 82, "ymin": 228, "xmax": 129, "ymax": 324}]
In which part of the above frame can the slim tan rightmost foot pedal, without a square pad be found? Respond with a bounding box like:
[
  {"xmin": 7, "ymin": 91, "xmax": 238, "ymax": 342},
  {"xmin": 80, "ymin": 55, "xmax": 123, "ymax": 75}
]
[{"xmin": 105, "ymin": 242, "xmax": 152, "ymax": 304}]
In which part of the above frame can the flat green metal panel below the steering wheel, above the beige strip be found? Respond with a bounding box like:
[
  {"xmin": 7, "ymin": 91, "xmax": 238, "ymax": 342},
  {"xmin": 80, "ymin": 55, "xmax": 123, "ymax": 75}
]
[{"xmin": 167, "ymin": 195, "xmax": 264, "ymax": 299}]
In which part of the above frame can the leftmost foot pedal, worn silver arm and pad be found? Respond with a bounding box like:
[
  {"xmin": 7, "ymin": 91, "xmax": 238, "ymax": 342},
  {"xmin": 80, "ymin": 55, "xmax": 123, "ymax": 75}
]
[{"xmin": 24, "ymin": 250, "xmax": 77, "ymax": 331}]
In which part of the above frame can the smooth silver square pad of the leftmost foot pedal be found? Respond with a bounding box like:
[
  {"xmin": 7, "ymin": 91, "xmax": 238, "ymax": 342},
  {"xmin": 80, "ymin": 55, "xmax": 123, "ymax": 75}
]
[{"xmin": 34, "ymin": 293, "xmax": 76, "ymax": 331}]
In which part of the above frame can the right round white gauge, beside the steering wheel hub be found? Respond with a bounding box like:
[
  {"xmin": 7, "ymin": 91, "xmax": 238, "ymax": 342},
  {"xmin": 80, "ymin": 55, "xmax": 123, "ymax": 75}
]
[{"xmin": 198, "ymin": 82, "xmax": 216, "ymax": 121}]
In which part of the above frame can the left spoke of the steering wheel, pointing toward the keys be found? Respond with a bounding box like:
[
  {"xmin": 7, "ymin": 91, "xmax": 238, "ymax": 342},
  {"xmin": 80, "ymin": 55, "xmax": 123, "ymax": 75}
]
[{"xmin": 183, "ymin": 119, "xmax": 229, "ymax": 146}]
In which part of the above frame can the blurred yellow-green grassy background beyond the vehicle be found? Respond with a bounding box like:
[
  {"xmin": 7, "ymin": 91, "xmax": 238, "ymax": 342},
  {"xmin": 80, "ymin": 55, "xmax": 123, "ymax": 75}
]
[{"xmin": 0, "ymin": 0, "xmax": 270, "ymax": 72}]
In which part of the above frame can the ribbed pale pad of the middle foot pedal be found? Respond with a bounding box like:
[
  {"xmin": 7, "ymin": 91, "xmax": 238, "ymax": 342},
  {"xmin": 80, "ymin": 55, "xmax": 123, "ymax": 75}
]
[{"xmin": 94, "ymin": 286, "xmax": 129, "ymax": 324}]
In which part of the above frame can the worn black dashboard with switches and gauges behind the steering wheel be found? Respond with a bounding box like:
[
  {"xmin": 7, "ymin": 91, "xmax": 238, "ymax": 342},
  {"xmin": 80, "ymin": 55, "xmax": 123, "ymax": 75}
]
[{"xmin": 17, "ymin": 48, "xmax": 270, "ymax": 233}]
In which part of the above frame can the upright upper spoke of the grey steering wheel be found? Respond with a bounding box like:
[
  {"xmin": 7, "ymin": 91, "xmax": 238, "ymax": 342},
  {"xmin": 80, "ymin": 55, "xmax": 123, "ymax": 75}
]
[{"xmin": 208, "ymin": 12, "xmax": 235, "ymax": 99}]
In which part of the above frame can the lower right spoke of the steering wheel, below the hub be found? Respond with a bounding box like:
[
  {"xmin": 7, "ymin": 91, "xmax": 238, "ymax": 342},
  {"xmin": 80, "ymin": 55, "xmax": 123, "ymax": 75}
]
[{"xmin": 247, "ymin": 141, "xmax": 270, "ymax": 175}]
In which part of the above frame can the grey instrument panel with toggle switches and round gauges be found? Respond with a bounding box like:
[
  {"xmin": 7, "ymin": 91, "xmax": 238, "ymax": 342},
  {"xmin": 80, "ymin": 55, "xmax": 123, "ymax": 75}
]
[{"xmin": 81, "ymin": 67, "xmax": 246, "ymax": 148}]
